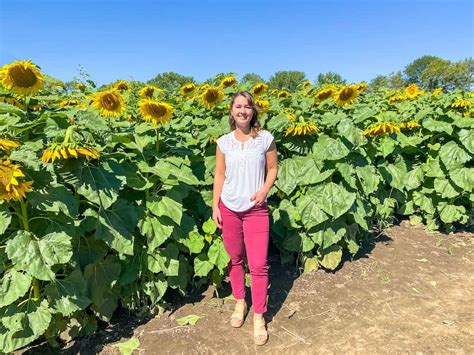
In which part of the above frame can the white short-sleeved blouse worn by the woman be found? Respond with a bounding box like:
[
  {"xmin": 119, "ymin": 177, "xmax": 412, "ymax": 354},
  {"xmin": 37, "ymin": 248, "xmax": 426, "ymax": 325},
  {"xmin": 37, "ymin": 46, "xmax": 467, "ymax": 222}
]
[{"xmin": 217, "ymin": 130, "xmax": 273, "ymax": 212}]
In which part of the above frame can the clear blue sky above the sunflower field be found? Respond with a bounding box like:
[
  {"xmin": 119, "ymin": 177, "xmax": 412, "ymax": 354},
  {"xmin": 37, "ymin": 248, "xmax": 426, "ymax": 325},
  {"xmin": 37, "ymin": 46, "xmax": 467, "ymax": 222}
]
[{"xmin": 0, "ymin": 0, "xmax": 474, "ymax": 84}]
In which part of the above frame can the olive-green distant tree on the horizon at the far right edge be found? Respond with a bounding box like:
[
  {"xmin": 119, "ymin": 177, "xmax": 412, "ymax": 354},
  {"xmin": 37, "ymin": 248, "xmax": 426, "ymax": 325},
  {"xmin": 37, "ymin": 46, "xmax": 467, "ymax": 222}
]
[{"xmin": 420, "ymin": 58, "xmax": 474, "ymax": 90}]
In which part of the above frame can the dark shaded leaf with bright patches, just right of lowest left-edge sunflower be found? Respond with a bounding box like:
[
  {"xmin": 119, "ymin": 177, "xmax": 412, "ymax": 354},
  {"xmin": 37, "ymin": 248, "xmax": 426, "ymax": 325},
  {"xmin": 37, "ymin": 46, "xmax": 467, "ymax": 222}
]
[{"xmin": 28, "ymin": 185, "xmax": 78, "ymax": 218}]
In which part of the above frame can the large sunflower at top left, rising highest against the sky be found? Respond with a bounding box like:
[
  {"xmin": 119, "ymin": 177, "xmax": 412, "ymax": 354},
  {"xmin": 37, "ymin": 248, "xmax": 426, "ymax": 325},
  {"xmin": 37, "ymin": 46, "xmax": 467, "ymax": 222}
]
[{"xmin": 0, "ymin": 60, "xmax": 44, "ymax": 95}]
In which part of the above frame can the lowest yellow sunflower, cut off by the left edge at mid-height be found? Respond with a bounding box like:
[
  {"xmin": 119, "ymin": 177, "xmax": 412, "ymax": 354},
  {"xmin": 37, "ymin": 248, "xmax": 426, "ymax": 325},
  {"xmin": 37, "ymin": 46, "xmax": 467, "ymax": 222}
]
[{"xmin": 0, "ymin": 160, "xmax": 33, "ymax": 201}]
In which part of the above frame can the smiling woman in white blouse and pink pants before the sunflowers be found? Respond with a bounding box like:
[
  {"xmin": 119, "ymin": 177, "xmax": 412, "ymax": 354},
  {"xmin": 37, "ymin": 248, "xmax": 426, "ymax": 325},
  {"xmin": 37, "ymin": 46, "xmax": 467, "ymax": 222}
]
[{"xmin": 212, "ymin": 91, "xmax": 278, "ymax": 345}]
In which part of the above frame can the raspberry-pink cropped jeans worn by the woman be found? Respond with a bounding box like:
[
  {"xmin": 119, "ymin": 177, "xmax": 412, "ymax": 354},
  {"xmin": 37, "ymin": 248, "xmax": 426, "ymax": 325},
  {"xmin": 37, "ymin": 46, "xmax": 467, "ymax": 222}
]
[{"xmin": 219, "ymin": 201, "xmax": 269, "ymax": 314}]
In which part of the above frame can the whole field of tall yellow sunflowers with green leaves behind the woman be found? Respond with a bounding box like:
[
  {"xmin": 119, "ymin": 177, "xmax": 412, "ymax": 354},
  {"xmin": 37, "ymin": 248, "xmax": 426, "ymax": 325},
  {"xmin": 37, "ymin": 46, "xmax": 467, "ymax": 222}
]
[{"xmin": 0, "ymin": 61, "xmax": 474, "ymax": 352}]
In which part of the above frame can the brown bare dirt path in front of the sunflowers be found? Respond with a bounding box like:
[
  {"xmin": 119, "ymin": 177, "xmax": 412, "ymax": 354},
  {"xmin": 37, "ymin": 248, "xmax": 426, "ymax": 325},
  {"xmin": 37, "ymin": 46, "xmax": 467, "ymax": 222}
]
[{"xmin": 26, "ymin": 222, "xmax": 474, "ymax": 354}]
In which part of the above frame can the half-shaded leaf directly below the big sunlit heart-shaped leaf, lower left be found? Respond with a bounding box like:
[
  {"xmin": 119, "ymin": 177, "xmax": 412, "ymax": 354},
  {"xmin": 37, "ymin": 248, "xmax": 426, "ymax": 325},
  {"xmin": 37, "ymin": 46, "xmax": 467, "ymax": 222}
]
[{"xmin": 44, "ymin": 270, "xmax": 91, "ymax": 317}]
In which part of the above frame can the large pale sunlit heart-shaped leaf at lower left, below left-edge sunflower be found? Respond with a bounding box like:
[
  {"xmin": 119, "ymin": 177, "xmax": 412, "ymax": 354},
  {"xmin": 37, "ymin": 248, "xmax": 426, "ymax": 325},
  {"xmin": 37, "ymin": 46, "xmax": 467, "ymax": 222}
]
[{"xmin": 6, "ymin": 231, "xmax": 72, "ymax": 281}]
